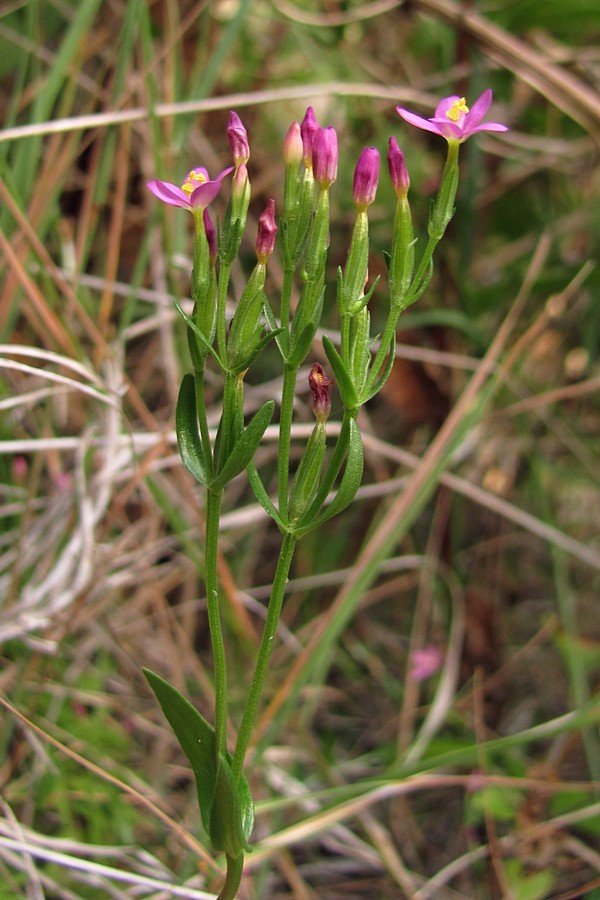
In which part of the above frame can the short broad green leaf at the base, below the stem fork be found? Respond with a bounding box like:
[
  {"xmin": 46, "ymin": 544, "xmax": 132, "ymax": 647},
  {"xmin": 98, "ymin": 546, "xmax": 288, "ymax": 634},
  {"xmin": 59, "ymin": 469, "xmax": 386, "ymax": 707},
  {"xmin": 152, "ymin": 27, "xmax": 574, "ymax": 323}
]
[{"xmin": 210, "ymin": 753, "xmax": 254, "ymax": 859}]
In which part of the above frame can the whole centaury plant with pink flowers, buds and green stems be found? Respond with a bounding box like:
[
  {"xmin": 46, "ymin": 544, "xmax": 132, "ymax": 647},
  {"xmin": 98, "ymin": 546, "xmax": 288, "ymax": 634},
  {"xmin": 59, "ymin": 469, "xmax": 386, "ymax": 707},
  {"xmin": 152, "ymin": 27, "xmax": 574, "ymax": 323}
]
[{"xmin": 145, "ymin": 90, "xmax": 505, "ymax": 900}]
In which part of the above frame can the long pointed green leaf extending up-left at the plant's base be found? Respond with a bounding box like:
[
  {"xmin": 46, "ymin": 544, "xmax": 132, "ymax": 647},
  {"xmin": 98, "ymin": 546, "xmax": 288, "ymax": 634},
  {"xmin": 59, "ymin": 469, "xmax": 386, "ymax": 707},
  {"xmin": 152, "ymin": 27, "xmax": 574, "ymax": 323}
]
[{"xmin": 142, "ymin": 669, "xmax": 218, "ymax": 836}]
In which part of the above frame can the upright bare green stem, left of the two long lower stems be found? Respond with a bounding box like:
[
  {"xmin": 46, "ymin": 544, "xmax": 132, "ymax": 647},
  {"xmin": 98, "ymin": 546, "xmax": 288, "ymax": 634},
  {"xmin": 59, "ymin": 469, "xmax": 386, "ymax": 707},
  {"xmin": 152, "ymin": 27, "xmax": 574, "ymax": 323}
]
[{"xmin": 204, "ymin": 489, "xmax": 227, "ymax": 763}]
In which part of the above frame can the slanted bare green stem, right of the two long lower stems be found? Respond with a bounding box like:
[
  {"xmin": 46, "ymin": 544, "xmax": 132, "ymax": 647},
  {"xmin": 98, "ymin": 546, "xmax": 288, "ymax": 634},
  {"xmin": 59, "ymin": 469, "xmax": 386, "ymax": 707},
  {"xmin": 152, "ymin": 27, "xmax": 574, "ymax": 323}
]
[{"xmin": 231, "ymin": 534, "xmax": 296, "ymax": 779}]
